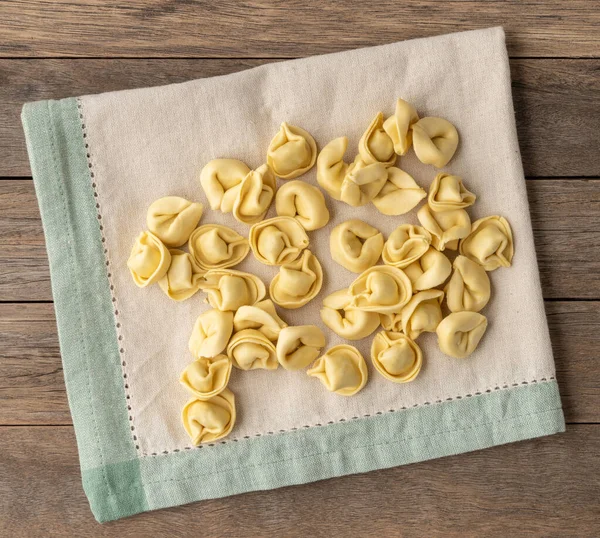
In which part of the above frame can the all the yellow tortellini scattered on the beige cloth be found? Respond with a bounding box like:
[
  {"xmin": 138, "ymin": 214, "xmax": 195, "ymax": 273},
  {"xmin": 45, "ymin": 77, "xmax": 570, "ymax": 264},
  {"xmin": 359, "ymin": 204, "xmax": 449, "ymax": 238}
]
[{"xmin": 127, "ymin": 99, "xmax": 514, "ymax": 445}]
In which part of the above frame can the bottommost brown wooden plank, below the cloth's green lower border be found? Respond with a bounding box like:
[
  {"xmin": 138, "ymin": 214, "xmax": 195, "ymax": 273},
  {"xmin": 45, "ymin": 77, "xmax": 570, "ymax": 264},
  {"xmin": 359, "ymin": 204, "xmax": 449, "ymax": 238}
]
[{"xmin": 0, "ymin": 425, "xmax": 600, "ymax": 538}]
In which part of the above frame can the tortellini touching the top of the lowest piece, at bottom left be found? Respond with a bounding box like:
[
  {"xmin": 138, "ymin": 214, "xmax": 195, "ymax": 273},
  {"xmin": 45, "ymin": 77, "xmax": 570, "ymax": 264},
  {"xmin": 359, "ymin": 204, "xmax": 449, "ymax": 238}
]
[{"xmin": 179, "ymin": 355, "xmax": 232, "ymax": 400}]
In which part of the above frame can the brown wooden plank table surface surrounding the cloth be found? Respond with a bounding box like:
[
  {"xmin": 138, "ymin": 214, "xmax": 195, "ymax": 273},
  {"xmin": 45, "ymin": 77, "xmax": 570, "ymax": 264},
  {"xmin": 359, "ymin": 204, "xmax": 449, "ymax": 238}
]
[{"xmin": 0, "ymin": 0, "xmax": 600, "ymax": 537}]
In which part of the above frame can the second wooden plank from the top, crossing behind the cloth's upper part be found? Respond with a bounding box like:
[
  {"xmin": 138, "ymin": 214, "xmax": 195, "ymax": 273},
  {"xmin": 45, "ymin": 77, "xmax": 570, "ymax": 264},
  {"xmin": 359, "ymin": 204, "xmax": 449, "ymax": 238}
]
[{"xmin": 0, "ymin": 59, "xmax": 600, "ymax": 177}]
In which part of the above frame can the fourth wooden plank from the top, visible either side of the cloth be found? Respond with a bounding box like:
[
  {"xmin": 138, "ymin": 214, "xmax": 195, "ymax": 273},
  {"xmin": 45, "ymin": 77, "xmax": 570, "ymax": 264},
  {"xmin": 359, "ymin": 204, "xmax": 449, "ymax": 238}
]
[{"xmin": 0, "ymin": 301, "xmax": 600, "ymax": 425}]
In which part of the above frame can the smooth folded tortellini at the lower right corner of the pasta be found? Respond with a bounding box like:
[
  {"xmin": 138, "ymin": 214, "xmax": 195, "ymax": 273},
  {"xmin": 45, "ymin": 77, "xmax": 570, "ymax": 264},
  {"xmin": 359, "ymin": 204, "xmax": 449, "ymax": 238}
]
[{"xmin": 436, "ymin": 312, "xmax": 487, "ymax": 359}]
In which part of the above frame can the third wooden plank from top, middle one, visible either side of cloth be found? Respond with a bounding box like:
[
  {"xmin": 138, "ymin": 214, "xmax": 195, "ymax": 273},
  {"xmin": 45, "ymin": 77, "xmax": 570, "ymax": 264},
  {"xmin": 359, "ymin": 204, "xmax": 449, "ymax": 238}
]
[{"xmin": 0, "ymin": 179, "xmax": 600, "ymax": 302}]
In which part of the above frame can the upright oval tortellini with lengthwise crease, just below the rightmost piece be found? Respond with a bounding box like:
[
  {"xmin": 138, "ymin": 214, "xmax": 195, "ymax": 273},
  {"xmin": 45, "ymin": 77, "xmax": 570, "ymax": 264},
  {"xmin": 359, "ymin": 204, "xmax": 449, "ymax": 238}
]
[{"xmin": 444, "ymin": 256, "xmax": 491, "ymax": 312}]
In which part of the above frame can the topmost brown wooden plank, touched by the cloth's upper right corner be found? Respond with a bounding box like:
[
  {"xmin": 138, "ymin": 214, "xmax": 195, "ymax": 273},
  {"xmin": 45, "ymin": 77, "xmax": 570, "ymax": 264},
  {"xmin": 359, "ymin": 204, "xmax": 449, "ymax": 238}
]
[{"xmin": 0, "ymin": 0, "xmax": 600, "ymax": 57}]
